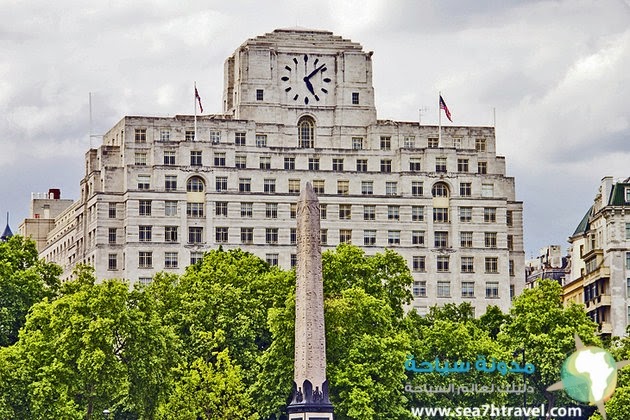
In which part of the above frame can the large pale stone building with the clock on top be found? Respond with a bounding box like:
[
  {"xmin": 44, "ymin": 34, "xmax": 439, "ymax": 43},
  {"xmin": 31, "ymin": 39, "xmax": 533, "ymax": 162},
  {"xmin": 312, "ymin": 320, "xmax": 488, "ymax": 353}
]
[{"xmin": 27, "ymin": 29, "xmax": 524, "ymax": 314}]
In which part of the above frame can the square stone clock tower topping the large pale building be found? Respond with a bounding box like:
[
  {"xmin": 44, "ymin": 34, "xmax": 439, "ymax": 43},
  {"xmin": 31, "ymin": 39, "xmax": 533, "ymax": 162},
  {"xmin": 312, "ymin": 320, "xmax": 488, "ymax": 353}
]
[{"xmin": 223, "ymin": 28, "xmax": 376, "ymax": 133}]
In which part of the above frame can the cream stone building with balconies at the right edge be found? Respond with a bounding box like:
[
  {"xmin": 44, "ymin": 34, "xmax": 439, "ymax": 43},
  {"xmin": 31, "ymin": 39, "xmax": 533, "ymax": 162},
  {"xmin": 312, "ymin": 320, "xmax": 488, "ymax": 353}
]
[{"xmin": 564, "ymin": 177, "xmax": 630, "ymax": 336}]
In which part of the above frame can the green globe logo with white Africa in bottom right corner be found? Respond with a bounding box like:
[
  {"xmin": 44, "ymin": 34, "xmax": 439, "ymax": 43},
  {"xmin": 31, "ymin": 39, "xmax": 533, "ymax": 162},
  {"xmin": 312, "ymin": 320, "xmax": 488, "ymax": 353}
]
[{"xmin": 547, "ymin": 334, "xmax": 630, "ymax": 419}]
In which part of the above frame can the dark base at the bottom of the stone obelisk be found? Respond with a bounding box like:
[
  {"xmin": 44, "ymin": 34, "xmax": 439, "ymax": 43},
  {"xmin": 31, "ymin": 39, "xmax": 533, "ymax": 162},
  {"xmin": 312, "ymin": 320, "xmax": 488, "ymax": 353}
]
[{"xmin": 287, "ymin": 380, "xmax": 333, "ymax": 420}]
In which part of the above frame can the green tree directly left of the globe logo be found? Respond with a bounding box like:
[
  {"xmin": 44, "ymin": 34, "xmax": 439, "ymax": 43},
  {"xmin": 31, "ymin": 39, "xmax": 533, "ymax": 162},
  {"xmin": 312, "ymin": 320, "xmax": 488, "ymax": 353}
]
[{"xmin": 498, "ymin": 279, "xmax": 601, "ymax": 414}]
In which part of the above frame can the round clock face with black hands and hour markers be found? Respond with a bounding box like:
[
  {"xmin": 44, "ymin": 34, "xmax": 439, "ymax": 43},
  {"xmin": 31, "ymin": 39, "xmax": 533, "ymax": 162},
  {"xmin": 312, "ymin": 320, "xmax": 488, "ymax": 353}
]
[{"xmin": 280, "ymin": 54, "xmax": 332, "ymax": 105}]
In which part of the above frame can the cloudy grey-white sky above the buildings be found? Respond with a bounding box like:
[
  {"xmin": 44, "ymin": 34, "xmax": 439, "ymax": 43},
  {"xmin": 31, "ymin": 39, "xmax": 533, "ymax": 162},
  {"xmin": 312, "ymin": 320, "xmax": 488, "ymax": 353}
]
[{"xmin": 0, "ymin": 0, "xmax": 630, "ymax": 257}]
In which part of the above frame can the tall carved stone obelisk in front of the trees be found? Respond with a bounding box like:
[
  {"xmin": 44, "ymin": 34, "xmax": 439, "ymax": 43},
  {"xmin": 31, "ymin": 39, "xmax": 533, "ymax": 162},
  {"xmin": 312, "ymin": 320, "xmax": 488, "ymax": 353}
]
[{"xmin": 287, "ymin": 182, "xmax": 333, "ymax": 420}]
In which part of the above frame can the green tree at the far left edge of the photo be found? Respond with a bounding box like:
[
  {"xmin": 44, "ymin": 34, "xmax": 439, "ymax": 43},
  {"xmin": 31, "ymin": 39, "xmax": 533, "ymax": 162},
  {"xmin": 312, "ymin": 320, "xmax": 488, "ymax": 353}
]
[{"xmin": 0, "ymin": 236, "xmax": 61, "ymax": 346}]
